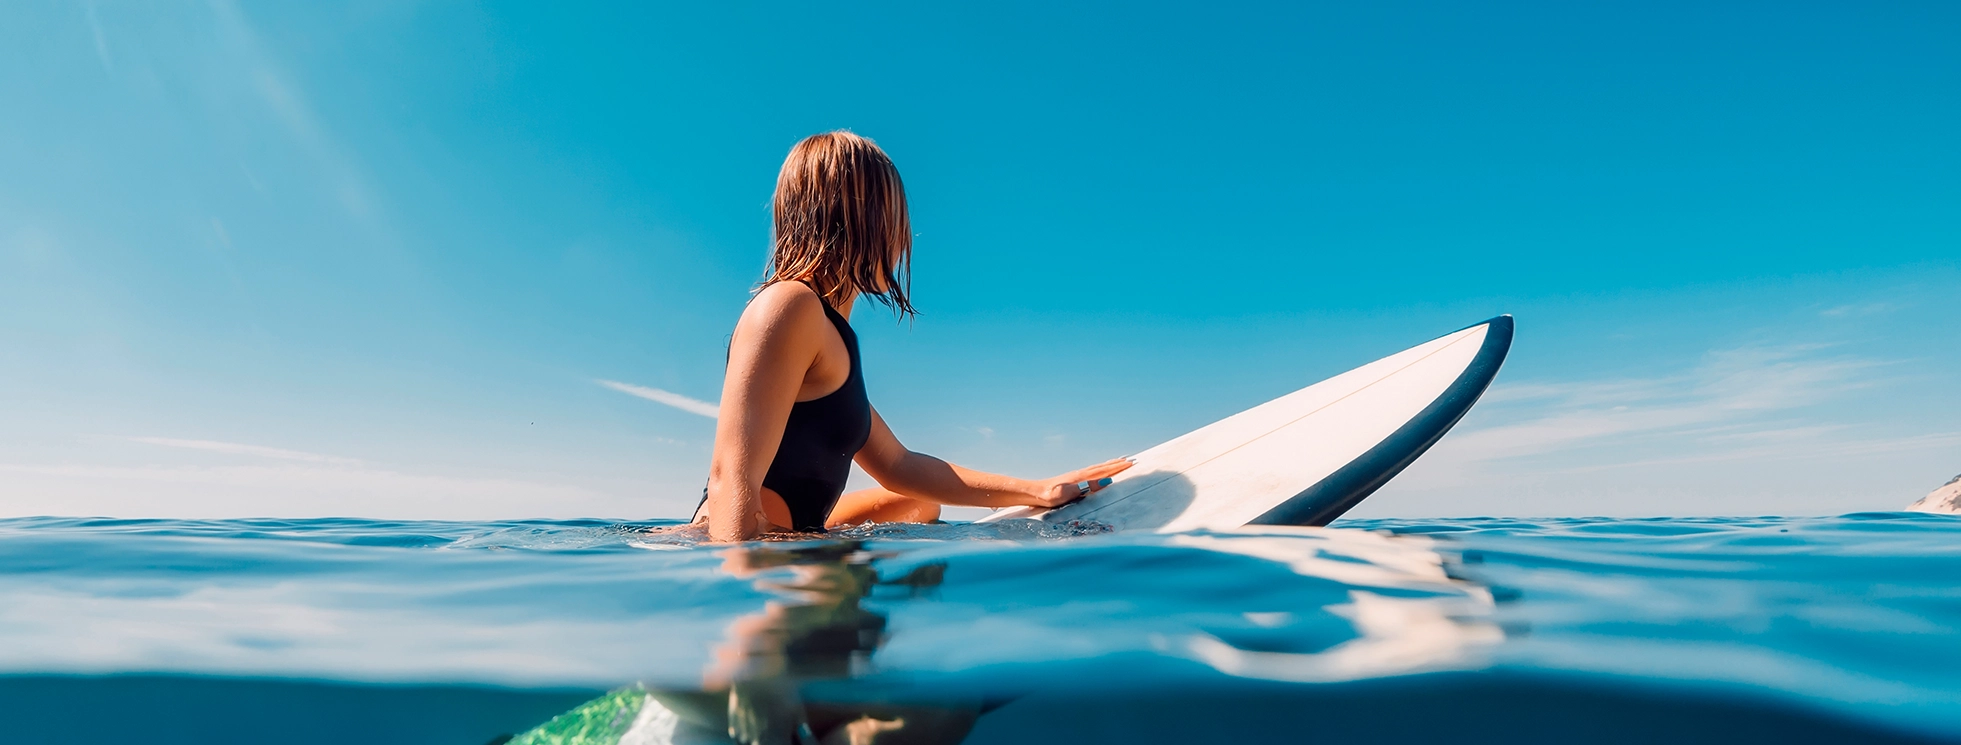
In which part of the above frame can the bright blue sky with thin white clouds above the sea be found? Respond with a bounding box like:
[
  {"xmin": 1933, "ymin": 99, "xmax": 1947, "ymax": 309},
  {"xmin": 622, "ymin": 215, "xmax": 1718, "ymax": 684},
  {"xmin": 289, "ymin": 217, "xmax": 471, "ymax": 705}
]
[{"xmin": 0, "ymin": 0, "xmax": 1961, "ymax": 520}]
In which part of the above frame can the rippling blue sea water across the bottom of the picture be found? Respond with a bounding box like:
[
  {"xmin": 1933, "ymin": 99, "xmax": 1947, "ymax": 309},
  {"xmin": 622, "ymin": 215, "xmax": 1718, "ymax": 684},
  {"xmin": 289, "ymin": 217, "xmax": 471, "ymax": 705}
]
[{"xmin": 0, "ymin": 514, "xmax": 1961, "ymax": 745}]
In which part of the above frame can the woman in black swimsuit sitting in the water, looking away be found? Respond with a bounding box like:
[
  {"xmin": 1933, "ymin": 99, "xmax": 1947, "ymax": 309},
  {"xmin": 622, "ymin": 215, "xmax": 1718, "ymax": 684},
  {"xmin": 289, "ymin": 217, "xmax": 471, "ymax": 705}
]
[{"xmin": 694, "ymin": 131, "xmax": 1130, "ymax": 541}]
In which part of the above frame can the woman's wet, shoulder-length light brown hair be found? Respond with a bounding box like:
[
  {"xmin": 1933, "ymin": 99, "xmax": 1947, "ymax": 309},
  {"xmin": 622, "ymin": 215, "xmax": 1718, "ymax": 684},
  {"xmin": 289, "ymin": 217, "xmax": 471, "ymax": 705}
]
[{"xmin": 759, "ymin": 129, "xmax": 914, "ymax": 316}]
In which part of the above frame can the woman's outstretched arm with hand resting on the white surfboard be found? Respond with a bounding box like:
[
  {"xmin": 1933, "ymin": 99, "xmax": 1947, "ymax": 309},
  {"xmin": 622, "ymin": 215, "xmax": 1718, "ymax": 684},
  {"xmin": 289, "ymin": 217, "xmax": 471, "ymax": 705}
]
[{"xmin": 857, "ymin": 410, "xmax": 1131, "ymax": 508}]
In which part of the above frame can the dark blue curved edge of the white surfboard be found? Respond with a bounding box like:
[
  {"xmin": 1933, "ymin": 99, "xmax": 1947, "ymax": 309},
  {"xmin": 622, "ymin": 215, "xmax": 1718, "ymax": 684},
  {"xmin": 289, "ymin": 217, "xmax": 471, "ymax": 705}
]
[{"xmin": 1251, "ymin": 316, "xmax": 1512, "ymax": 525}]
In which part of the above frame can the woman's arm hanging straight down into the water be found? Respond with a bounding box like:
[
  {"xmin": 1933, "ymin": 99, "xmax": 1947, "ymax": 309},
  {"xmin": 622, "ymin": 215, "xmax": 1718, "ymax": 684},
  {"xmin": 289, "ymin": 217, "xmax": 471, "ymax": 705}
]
[{"xmin": 706, "ymin": 282, "xmax": 830, "ymax": 541}]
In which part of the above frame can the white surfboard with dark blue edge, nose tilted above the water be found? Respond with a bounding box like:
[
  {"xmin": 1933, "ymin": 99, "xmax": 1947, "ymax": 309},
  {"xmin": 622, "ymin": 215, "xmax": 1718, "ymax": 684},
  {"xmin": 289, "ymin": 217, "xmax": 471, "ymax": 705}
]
[{"xmin": 981, "ymin": 316, "xmax": 1512, "ymax": 531}]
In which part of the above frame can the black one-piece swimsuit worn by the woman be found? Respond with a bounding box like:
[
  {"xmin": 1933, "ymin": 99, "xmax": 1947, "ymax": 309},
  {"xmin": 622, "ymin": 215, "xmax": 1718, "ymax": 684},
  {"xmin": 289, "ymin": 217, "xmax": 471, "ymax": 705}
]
[{"xmin": 702, "ymin": 294, "xmax": 871, "ymax": 531}]
